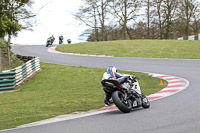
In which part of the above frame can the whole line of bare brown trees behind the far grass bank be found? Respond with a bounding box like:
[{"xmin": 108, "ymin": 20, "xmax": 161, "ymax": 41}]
[{"xmin": 77, "ymin": 0, "xmax": 200, "ymax": 41}]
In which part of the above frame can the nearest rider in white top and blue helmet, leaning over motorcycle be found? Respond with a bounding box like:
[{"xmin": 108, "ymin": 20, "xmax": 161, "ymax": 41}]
[{"xmin": 102, "ymin": 66, "xmax": 141, "ymax": 106}]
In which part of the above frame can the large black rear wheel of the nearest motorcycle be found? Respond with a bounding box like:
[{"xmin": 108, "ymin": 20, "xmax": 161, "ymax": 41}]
[{"xmin": 112, "ymin": 91, "xmax": 132, "ymax": 113}]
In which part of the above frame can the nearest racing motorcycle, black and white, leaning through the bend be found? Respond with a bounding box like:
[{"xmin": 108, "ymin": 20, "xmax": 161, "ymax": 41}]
[{"xmin": 101, "ymin": 76, "xmax": 150, "ymax": 113}]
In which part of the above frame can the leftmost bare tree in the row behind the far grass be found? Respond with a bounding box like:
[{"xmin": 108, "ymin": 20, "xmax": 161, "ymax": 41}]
[{"xmin": 74, "ymin": 0, "xmax": 109, "ymax": 41}]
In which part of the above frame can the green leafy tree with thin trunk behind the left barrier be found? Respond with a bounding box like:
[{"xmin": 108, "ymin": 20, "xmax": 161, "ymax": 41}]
[{"xmin": 0, "ymin": 0, "xmax": 35, "ymax": 65}]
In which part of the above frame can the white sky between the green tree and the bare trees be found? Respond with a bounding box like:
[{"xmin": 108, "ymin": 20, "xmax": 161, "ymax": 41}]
[{"xmin": 12, "ymin": 0, "xmax": 87, "ymax": 44}]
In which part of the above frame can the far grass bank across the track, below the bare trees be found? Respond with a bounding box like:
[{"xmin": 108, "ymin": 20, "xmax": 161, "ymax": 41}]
[{"xmin": 56, "ymin": 40, "xmax": 200, "ymax": 59}]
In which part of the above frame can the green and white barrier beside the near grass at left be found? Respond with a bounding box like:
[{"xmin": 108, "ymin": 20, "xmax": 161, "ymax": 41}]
[{"xmin": 0, "ymin": 57, "xmax": 40, "ymax": 90}]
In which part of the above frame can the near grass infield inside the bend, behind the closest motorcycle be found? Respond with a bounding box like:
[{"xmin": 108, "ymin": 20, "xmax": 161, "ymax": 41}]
[{"xmin": 0, "ymin": 63, "xmax": 167, "ymax": 129}]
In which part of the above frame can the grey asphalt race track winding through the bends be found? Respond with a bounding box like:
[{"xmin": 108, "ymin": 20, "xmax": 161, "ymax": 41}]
[{"xmin": 0, "ymin": 45, "xmax": 200, "ymax": 133}]
